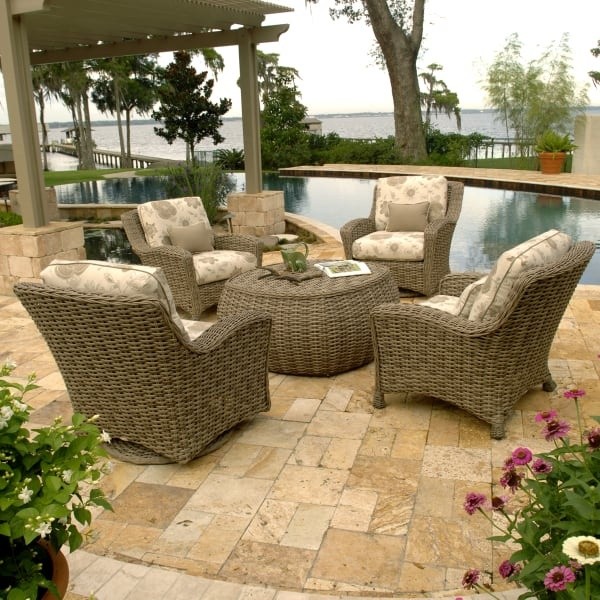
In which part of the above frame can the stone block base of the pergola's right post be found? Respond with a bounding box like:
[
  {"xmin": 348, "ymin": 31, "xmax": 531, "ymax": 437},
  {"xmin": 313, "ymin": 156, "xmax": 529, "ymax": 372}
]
[{"xmin": 227, "ymin": 190, "xmax": 285, "ymax": 237}]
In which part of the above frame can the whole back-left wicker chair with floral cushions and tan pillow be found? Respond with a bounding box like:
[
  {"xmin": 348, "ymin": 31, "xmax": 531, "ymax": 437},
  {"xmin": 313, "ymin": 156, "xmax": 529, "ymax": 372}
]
[{"xmin": 121, "ymin": 196, "xmax": 262, "ymax": 319}]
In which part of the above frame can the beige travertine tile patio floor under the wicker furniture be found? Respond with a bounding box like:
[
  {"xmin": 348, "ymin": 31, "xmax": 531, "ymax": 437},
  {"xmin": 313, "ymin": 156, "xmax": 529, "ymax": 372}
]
[{"xmin": 0, "ymin": 223, "xmax": 600, "ymax": 600}]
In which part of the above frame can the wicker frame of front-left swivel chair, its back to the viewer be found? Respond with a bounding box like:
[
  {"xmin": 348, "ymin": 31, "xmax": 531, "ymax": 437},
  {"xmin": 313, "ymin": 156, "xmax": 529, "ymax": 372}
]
[{"xmin": 14, "ymin": 282, "xmax": 271, "ymax": 464}]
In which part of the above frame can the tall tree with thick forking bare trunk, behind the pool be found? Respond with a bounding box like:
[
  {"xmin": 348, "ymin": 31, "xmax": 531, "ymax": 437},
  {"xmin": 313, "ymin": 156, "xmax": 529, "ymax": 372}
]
[{"xmin": 305, "ymin": 0, "xmax": 427, "ymax": 162}]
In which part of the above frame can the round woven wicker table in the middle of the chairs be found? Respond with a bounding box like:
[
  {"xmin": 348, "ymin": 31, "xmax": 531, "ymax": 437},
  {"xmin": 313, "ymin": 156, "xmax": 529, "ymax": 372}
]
[{"xmin": 217, "ymin": 263, "xmax": 399, "ymax": 376}]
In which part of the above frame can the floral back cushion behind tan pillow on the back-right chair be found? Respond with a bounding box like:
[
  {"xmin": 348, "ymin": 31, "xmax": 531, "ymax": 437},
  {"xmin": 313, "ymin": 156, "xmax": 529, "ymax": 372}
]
[{"xmin": 373, "ymin": 175, "xmax": 448, "ymax": 231}]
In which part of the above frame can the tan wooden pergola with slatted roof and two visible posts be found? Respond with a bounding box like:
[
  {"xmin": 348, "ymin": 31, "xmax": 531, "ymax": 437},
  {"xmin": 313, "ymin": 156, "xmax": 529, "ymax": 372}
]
[{"xmin": 0, "ymin": 0, "xmax": 292, "ymax": 227}]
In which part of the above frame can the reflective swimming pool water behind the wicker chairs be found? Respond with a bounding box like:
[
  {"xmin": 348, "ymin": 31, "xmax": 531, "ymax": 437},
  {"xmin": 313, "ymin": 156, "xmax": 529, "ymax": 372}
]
[{"xmin": 56, "ymin": 173, "xmax": 600, "ymax": 284}]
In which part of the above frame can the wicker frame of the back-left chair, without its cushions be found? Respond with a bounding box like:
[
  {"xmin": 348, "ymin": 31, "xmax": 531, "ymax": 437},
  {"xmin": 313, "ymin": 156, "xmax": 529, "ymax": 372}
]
[{"xmin": 121, "ymin": 210, "xmax": 262, "ymax": 319}]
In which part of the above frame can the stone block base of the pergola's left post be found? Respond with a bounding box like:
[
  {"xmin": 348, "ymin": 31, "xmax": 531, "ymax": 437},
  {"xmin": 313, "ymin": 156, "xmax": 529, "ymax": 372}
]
[{"xmin": 0, "ymin": 221, "xmax": 86, "ymax": 296}]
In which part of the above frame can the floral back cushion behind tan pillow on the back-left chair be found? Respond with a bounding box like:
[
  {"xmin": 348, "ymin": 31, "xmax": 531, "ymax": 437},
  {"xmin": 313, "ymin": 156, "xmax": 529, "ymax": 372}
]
[{"xmin": 138, "ymin": 196, "xmax": 210, "ymax": 248}]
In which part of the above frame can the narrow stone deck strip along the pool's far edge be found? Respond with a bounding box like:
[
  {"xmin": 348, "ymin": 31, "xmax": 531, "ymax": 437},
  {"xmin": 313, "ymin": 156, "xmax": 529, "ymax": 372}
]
[{"xmin": 279, "ymin": 164, "xmax": 600, "ymax": 200}]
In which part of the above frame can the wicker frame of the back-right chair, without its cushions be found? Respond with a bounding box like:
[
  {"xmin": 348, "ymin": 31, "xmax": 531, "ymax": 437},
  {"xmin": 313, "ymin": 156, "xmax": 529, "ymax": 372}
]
[{"xmin": 340, "ymin": 181, "xmax": 464, "ymax": 296}]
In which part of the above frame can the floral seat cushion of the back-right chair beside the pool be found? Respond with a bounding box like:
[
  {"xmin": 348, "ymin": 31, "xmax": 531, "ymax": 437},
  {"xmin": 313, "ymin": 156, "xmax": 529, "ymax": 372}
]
[{"xmin": 352, "ymin": 231, "xmax": 425, "ymax": 261}]
